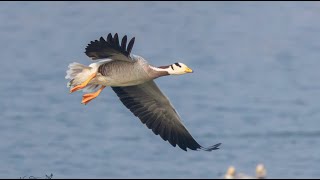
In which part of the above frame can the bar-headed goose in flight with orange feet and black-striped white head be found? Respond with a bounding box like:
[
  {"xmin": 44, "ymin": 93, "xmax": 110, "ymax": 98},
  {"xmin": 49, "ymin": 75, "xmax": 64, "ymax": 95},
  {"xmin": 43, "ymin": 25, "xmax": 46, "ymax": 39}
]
[{"xmin": 65, "ymin": 33, "xmax": 221, "ymax": 151}]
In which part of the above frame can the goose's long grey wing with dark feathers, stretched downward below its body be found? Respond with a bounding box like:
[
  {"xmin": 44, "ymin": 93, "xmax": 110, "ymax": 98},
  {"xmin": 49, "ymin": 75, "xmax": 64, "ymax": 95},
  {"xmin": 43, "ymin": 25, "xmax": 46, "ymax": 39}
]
[{"xmin": 112, "ymin": 80, "xmax": 221, "ymax": 151}]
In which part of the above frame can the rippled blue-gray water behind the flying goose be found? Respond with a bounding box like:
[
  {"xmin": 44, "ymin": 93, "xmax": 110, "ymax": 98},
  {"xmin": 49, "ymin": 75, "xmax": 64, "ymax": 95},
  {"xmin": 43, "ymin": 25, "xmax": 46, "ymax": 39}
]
[{"xmin": 0, "ymin": 2, "xmax": 320, "ymax": 178}]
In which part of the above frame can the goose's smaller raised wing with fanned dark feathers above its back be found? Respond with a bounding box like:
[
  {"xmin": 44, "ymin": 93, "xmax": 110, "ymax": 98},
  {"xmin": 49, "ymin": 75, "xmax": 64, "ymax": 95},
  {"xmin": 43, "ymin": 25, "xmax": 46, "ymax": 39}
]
[{"xmin": 85, "ymin": 33, "xmax": 135, "ymax": 62}]
